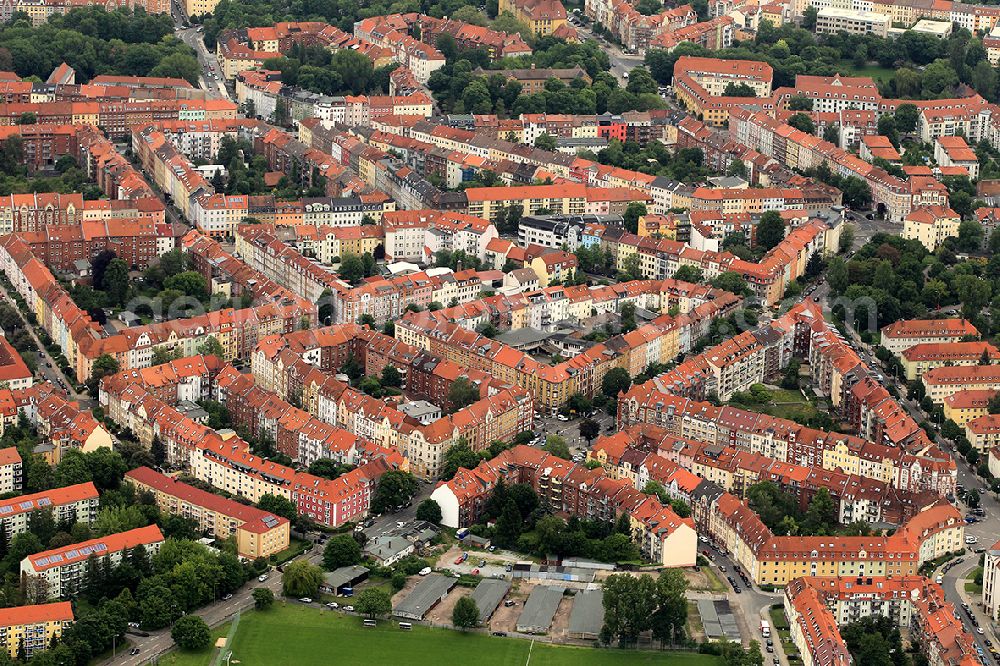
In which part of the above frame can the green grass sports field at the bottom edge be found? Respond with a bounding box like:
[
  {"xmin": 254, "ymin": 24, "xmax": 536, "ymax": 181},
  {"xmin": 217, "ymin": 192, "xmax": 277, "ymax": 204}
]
[{"xmin": 215, "ymin": 603, "xmax": 721, "ymax": 666}]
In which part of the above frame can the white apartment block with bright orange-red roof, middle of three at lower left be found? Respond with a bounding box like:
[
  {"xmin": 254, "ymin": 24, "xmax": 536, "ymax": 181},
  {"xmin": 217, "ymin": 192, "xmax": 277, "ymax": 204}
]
[{"xmin": 21, "ymin": 525, "xmax": 163, "ymax": 599}]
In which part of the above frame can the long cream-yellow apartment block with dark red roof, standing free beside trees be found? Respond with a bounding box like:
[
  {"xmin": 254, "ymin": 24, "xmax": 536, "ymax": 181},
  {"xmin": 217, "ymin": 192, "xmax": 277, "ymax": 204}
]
[{"xmin": 125, "ymin": 467, "xmax": 290, "ymax": 560}]
